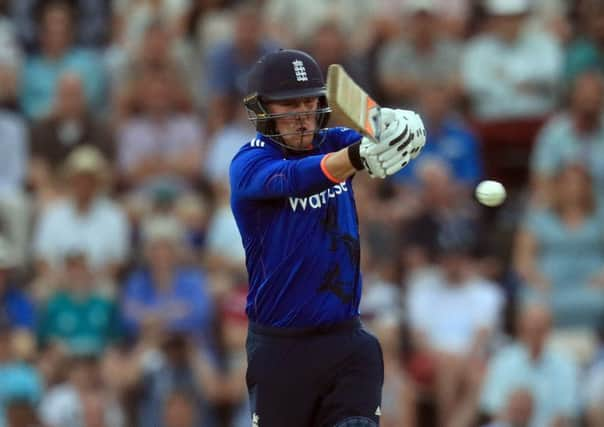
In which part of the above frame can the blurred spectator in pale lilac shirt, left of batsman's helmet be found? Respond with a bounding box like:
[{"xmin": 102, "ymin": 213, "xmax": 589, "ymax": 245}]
[{"xmin": 117, "ymin": 68, "xmax": 204, "ymax": 195}]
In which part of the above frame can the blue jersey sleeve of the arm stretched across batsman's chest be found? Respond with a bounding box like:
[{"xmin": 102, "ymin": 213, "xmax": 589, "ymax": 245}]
[{"xmin": 230, "ymin": 148, "xmax": 334, "ymax": 199}]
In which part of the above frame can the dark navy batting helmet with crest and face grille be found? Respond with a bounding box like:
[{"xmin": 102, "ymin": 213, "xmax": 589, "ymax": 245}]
[{"xmin": 243, "ymin": 49, "xmax": 331, "ymax": 148}]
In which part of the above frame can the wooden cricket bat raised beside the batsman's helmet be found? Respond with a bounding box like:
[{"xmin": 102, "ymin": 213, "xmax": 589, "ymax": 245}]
[{"xmin": 327, "ymin": 64, "xmax": 381, "ymax": 141}]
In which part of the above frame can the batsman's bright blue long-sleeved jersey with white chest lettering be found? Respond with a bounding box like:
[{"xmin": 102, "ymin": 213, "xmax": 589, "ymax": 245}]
[{"xmin": 230, "ymin": 128, "xmax": 361, "ymax": 327}]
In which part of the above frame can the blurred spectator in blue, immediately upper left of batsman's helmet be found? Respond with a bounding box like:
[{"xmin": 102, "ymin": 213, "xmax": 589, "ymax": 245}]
[{"xmin": 202, "ymin": 3, "xmax": 278, "ymax": 131}]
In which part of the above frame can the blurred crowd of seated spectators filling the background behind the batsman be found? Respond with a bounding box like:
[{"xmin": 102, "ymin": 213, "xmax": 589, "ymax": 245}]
[{"xmin": 0, "ymin": 0, "xmax": 604, "ymax": 427}]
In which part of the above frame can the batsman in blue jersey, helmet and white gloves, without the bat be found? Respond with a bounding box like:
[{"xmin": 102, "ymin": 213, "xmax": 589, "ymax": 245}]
[{"xmin": 230, "ymin": 50, "xmax": 426, "ymax": 427}]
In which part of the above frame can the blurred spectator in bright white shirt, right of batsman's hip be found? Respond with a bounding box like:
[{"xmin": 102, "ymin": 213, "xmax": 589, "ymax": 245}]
[{"xmin": 407, "ymin": 221, "xmax": 504, "ymax": 426}]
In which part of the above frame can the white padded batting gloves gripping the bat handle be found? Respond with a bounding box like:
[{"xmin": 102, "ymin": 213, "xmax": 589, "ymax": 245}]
[{"xmin": 359, "ymin": 108, "xmax": 426, "ymax": 178}]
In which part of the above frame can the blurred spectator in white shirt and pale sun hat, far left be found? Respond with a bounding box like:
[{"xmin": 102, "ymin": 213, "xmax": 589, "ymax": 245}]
[{"xmin": 33, "ymin": 146, "xmax": 130, "ymax": 290}]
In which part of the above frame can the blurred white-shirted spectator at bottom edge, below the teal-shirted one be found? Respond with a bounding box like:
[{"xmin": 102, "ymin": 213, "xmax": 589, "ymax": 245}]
[{"xmin": 39, "ymin": 355, "xmax": 125, "ymax": 427}]
